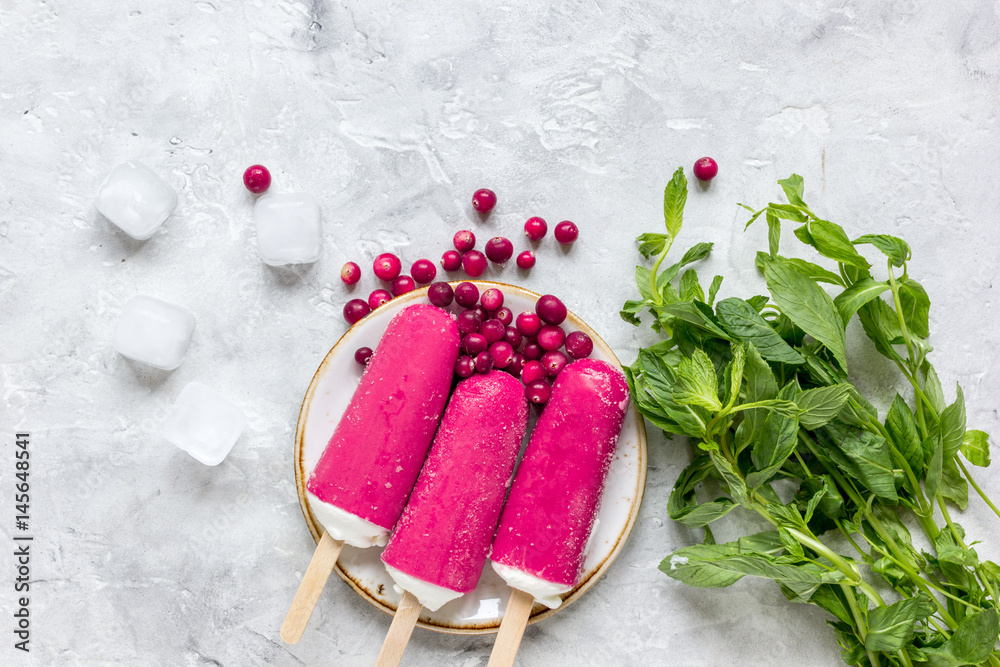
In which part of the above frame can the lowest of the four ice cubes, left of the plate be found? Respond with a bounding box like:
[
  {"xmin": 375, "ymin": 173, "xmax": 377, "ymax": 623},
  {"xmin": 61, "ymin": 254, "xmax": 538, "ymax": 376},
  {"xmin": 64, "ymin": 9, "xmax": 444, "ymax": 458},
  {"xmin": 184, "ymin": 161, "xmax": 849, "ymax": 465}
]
[{"xmin": 163, "ymin": 382, "xmax": 247, "ymax": 466}]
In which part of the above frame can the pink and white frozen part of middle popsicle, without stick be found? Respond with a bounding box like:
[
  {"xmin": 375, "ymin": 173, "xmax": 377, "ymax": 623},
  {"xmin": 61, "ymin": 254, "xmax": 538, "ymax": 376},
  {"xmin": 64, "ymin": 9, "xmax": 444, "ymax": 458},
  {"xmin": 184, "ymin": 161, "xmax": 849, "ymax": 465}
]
[{"xmin": 382, "ymin": 371, "xmax": 528, "ymax": 611}]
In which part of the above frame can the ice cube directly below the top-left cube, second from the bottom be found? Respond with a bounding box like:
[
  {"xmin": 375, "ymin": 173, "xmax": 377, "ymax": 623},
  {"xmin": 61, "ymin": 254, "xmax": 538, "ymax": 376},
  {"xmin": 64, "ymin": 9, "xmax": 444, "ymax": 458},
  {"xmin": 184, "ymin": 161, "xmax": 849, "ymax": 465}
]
[{"xmin": 114, "ymin": 294, "xmax": 194, "ymax": 371}]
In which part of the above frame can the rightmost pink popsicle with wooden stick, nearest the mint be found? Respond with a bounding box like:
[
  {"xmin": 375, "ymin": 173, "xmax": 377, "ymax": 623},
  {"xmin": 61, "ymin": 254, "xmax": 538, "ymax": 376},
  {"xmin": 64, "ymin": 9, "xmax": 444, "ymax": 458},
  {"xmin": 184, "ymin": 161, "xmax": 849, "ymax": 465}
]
[{"xmin": 482, "ymin": 359, "xmax": 629, "ymax": 666}]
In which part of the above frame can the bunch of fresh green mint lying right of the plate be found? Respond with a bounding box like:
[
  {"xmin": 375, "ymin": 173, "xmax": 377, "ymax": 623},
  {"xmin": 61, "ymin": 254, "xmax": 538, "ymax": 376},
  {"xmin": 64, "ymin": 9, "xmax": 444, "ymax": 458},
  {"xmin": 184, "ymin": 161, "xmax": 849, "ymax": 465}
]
[{"xmin": 621, "ymin": 169, "xmax": 1000, "ymax": 667}]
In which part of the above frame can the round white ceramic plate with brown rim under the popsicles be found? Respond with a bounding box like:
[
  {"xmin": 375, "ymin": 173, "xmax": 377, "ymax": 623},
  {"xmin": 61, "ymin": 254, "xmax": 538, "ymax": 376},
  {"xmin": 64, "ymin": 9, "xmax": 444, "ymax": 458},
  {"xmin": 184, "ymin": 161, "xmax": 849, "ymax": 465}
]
[{"xmin": 295, "ymin": 281, "xmax": 646, "ymax": 634}]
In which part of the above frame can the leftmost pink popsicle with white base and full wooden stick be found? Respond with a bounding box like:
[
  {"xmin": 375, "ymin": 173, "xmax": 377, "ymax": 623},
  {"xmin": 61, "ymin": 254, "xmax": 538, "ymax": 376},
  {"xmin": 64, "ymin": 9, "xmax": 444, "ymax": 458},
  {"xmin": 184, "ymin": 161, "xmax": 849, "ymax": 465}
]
[{"xmin": 281, "ymin": 304, "xmax": 459, "ymax": 643}]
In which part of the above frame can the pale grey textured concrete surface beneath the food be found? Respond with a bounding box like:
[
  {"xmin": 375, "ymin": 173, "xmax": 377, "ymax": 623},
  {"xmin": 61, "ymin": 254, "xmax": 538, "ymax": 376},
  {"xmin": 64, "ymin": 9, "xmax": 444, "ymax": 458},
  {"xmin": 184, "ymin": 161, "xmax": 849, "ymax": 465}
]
[{"xmin": 0, "ymin": 0, "xmax": 1000, "ymax": 667}]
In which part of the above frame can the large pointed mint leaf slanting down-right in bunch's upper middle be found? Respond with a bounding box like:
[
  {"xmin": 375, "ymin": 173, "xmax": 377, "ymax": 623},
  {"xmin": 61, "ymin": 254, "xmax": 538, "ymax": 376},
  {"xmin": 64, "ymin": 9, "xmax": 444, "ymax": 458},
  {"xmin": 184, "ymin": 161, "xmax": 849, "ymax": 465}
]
[{"xmin": 764, "ymin": 259, "xmax": 847, "ymax": 370}]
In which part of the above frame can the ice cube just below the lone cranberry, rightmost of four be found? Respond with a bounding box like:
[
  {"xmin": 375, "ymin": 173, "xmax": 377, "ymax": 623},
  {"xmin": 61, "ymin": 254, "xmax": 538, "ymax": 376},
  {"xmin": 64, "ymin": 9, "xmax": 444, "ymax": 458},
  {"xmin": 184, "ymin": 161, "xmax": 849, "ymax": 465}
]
[{"xmin": 253, "ymin": 193, "xmax": 323, "ymax": 266}]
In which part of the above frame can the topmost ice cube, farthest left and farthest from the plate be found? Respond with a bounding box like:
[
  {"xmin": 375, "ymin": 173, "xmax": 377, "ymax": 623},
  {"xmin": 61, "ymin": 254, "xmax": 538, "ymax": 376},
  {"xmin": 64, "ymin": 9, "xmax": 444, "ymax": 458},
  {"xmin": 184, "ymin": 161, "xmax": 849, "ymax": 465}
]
[{"xmin": 97, "ymin": 160, "xmax": 177, "ymax": 241}]
